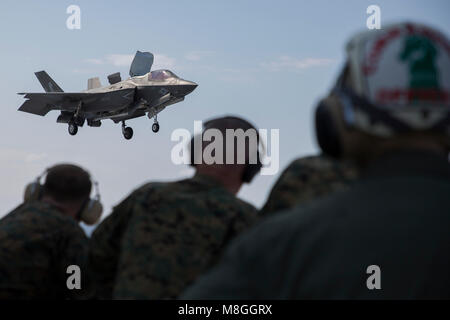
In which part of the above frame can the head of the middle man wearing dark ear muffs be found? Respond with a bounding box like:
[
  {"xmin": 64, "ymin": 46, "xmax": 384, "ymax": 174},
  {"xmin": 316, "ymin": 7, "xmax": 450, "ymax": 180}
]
[{"xmin": 190, "ymin": 116, "xmax": 263, "ymax": 182}]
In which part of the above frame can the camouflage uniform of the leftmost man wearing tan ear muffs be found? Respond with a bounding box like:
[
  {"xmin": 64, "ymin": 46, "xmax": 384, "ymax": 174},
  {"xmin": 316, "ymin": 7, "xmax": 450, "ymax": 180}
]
[{"xmin": 0, "ymin": 201, "xmax": 88, "ymax": 299}]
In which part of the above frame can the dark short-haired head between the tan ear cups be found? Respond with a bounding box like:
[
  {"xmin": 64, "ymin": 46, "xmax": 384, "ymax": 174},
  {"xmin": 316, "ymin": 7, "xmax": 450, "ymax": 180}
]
[{"xmin": 43, "ymin": 164, "xmax": 92, "ymax": 202}]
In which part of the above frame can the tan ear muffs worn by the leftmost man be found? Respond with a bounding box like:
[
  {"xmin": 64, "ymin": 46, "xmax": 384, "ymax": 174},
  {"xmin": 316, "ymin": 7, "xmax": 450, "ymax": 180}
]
[{"xmin": 23, "ymin": 169, "xmax": 103, "ymax": 225}]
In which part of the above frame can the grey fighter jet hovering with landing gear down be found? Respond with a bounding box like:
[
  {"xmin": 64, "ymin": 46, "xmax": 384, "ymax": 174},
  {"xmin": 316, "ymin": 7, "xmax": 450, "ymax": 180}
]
[{"xmin": 18, "ymin": 51, "xmax": 197, "ymax": 140}]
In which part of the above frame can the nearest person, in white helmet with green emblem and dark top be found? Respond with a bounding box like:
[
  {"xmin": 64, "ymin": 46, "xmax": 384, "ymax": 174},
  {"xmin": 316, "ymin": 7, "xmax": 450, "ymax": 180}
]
[{"xmin": 183, "ymin": 23, "xmax": 450, "ymax": 299}]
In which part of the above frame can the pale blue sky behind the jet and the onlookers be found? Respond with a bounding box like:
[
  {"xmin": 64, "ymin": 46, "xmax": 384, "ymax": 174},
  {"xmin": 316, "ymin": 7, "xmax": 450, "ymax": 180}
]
[{"xmin": 0, "ymin": 0, "xmax": 450, "ymax": 230}]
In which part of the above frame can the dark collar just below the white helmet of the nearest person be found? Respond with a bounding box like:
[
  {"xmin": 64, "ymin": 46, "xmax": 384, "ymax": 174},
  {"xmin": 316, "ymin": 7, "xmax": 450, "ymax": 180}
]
[{"xmin": 362, "ymin": 151, "xmax": 450, "ymax": 179}]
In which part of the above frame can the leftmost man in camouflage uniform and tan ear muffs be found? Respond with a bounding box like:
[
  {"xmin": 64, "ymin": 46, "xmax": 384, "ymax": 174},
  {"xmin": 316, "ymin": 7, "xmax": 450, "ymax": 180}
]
[{"xmin": 0, "ymin": 164, "xmax": 101, "ymax": 299}]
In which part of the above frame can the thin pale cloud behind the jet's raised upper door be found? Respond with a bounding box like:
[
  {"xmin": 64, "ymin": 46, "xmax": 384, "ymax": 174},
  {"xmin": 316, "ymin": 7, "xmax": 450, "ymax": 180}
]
[{"xmin": 84, "ymin": 53, "xmax": 176, "ymax": 69}]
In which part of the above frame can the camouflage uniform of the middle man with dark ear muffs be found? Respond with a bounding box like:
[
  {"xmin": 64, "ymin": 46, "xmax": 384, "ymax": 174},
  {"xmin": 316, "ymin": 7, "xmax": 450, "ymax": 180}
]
[{"xmin": 90, "ymin": 174, "xmax": 257, "ymax": 299}]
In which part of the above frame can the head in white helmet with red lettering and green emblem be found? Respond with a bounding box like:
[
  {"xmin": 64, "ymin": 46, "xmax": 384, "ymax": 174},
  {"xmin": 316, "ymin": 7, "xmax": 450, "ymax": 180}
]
[{"xmin": 316, "ymin": 23, "xmax": 450, "ymax": 164}]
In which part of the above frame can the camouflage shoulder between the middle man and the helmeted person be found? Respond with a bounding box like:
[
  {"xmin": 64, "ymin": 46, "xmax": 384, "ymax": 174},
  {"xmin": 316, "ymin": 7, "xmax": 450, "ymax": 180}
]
[{"xmin": 261, "ymin": 155, "xmax": 356, "ymax": 215}]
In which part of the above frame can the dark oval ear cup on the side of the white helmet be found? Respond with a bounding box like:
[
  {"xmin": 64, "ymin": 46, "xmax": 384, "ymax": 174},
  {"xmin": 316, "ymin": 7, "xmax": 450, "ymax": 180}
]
[{"xmin": 315, "ymin": 100, "xmax": 342, "ymax": 158}]
